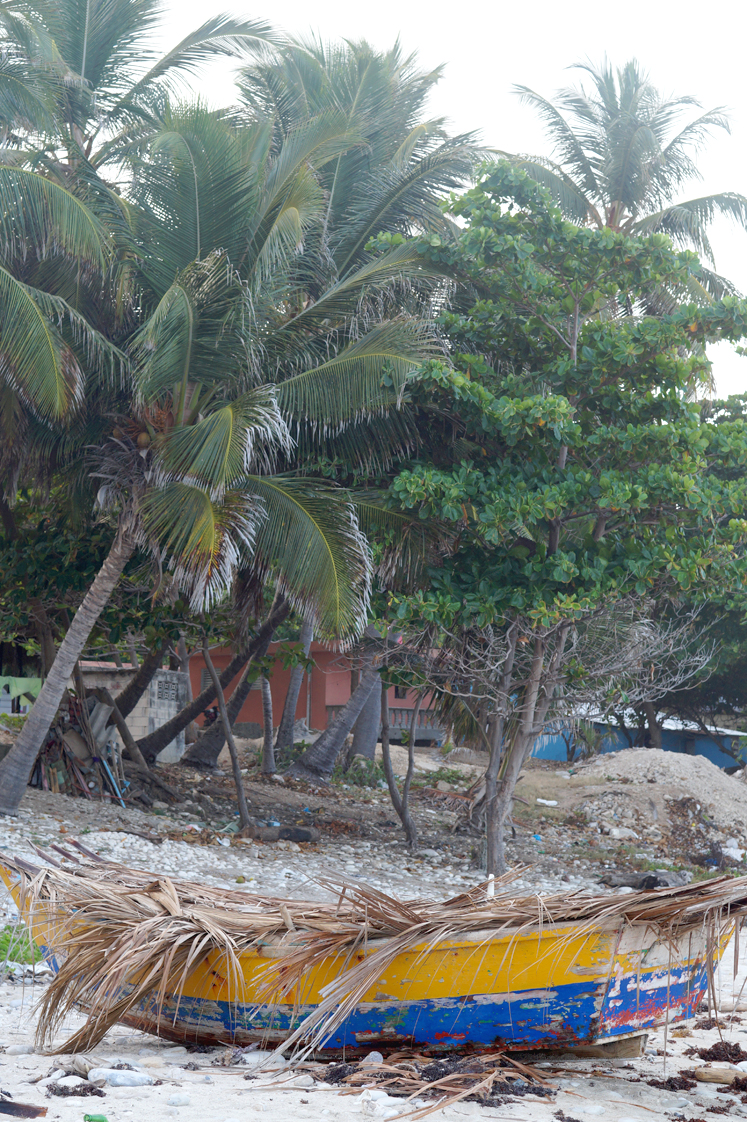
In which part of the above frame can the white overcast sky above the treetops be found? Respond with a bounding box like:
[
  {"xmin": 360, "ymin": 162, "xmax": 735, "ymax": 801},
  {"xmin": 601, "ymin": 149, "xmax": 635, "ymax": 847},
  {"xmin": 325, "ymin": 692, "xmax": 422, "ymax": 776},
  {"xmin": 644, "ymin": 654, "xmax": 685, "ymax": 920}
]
[{"xmin": 158, "ymin": 0, "xmax": 747, "ymax": 396}]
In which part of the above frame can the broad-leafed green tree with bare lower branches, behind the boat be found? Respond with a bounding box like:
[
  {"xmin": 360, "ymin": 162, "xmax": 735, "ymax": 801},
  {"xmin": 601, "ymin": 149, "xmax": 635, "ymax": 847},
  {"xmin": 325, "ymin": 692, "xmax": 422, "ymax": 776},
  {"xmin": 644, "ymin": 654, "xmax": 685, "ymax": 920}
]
[{"xmin": 391, "ymin": 165, "xmax": 747, "ymax": 871}]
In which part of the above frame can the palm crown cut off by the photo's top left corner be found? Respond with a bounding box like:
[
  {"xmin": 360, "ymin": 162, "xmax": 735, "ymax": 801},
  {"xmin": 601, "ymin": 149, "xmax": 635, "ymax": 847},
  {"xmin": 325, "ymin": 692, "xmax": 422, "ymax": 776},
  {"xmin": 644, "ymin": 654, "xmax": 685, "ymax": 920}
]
[{"xmin": 0, "ymin": 0, "xmax": 278, "ymax": 168}]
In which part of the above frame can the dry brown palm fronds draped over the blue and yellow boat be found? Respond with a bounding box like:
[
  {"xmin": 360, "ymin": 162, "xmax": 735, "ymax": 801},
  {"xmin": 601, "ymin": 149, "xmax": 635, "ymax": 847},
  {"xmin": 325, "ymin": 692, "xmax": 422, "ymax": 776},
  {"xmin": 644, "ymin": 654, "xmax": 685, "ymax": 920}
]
[{"xmin": 2, "ymin": 843, "xmax": 747, "ymax": 1052}]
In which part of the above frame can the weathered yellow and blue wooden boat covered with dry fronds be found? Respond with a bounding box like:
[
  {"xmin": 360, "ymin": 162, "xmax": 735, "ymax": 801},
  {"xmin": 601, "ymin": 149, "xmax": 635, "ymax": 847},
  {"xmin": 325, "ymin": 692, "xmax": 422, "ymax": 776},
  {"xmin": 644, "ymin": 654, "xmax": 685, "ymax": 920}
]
[{"xmin": 0, "ymin": 858, "xmax": 747, "ymax": 1057}]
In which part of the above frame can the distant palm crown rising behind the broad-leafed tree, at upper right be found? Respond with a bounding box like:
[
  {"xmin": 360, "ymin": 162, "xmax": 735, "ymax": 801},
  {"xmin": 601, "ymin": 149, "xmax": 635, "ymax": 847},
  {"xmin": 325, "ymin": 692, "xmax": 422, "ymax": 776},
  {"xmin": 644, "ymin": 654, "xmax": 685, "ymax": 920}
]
[{"xmin": 510, "ymin": 59, "xmax": 747, "ymax": 296}]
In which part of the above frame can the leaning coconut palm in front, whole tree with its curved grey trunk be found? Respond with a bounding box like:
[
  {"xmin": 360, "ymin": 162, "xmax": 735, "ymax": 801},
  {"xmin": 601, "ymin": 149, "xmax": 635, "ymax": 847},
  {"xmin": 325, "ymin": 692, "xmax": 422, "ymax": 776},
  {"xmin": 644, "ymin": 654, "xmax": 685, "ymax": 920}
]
[{"xmin": 0, "ymin": 96, "xmax": 444, "ymax": 811}]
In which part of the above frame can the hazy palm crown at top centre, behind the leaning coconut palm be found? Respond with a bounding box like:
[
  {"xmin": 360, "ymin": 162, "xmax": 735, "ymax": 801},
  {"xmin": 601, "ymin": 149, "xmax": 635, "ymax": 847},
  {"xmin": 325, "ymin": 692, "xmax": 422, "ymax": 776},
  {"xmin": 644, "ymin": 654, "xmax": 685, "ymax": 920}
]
[{"xmin": 238, "ymin": 38, "xmax": 485, "ymax": 276}]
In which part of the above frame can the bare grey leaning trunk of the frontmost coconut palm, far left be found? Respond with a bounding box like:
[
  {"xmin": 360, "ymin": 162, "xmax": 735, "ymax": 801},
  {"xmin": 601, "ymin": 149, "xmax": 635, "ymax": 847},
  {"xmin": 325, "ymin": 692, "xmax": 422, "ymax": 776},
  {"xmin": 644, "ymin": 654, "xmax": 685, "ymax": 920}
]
[{"xmin": 0, "ymin": 523, "xmax": 135, "ymax": 815}]
